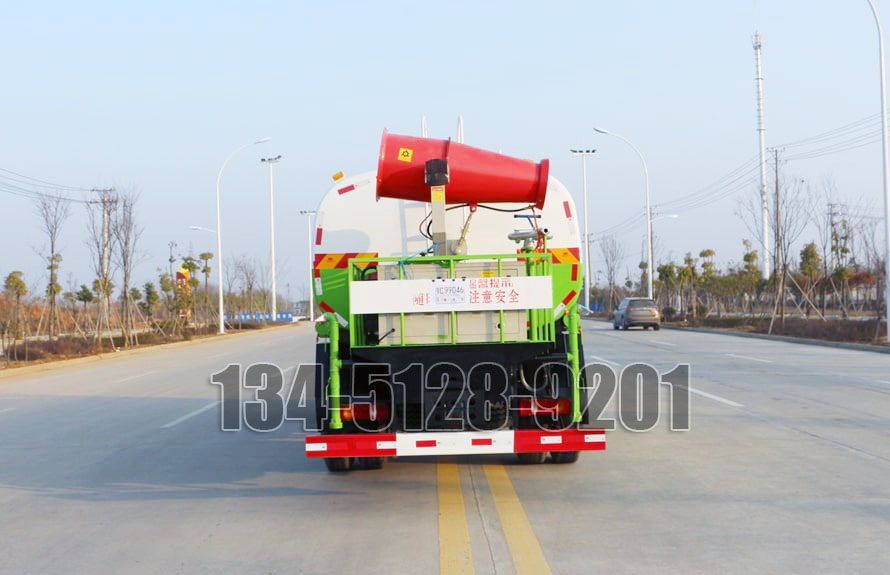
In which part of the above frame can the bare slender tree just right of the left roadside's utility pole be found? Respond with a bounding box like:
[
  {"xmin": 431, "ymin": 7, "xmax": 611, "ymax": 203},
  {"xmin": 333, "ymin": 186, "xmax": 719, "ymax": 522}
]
[{"xmin": 111, "ymin": 190, "xmax": 142, "ymax": 345}]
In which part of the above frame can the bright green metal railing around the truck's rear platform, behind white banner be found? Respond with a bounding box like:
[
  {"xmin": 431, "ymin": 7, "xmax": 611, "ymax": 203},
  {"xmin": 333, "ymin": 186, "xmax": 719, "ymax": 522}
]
[{"xmin": 346, "ymin": 252, "xmax": 552, "ymax": 348}]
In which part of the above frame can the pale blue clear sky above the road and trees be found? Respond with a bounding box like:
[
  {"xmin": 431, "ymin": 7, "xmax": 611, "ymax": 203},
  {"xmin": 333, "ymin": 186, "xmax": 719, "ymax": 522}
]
[{"xmin": 0, "ymin": 0, "xmax": 890, "ymax": 297}]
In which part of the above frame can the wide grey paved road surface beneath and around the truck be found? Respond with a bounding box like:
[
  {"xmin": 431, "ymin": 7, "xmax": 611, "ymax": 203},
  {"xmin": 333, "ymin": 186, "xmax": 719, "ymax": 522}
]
[{"xmin": 0, "ymin": 322, "xmax": 890, "ymax": 575}]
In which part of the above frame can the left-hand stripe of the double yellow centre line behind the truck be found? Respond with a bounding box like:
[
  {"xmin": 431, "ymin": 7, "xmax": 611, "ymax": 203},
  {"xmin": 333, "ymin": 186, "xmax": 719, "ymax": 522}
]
[{"xmin": 436, "ymin": 463, "xmax": 474, "ymax": 574}]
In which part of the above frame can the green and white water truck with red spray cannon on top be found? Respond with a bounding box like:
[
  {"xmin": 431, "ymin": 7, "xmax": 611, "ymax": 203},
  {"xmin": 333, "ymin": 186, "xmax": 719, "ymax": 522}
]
[{"xmin": 305, "ymin": 131, "xmax": 605, "ymax": 471}]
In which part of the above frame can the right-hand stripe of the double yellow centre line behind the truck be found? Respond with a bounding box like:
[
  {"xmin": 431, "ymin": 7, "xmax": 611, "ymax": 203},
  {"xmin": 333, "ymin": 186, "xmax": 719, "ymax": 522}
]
[{"xmin": 482, "ymin": 464, "xmax": 550, "ymax": 575}]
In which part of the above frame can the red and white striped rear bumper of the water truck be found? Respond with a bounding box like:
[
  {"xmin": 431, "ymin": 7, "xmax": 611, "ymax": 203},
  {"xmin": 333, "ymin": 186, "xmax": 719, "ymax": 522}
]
[{"xmin": 306, "ymin": 429, "xmax": 606, "ymax": 458}]
